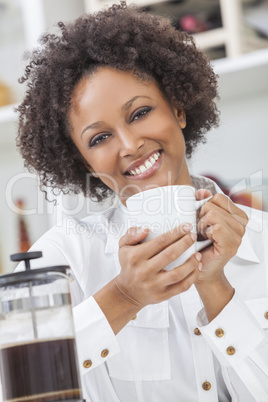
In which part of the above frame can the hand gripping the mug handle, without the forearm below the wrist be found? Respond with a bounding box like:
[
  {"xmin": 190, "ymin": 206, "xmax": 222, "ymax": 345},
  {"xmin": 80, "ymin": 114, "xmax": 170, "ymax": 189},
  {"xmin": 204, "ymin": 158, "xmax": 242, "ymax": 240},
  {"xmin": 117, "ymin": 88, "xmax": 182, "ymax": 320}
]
[{"xmin": 196, "ymin": 190, "xmax": 248, "ymax": 286}]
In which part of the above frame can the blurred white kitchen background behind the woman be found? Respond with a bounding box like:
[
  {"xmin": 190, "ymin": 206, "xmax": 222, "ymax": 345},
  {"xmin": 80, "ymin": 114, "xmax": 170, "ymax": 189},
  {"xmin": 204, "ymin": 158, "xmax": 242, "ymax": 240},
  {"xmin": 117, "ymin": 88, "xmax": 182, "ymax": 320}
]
[{"xmin": 0, "ymin": 0, "xmax": 268, "ymax": 273}]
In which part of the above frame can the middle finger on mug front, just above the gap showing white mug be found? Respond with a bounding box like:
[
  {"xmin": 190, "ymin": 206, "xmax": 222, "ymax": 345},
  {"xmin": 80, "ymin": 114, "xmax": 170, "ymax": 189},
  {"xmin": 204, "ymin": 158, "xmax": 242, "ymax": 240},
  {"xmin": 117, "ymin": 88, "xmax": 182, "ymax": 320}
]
[{"xmin": 150, "ymin": 229, "xmax": 197, "ymax": 270}]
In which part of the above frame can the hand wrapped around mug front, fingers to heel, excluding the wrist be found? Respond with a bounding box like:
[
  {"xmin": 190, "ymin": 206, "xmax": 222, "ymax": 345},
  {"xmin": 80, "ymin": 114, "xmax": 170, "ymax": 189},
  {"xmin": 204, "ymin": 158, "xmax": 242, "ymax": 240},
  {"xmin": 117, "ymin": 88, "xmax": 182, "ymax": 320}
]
[{"xmin": 115, "ymin": 224, "xmax": 202, "ymax": 308}]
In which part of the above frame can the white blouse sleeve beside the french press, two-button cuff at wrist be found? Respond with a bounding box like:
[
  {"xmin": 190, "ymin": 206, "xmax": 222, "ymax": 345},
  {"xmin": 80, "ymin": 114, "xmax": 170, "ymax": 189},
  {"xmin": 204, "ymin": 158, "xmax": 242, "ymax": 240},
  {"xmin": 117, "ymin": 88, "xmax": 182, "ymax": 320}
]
[{"xmin": 16, "ymin": 228, "xmax": 119, "ymax": 375}]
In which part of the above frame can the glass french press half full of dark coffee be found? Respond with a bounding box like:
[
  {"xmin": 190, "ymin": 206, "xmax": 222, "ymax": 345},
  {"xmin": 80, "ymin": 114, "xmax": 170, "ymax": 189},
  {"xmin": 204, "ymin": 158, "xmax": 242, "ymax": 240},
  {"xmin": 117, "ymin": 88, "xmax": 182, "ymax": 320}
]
[{"xmin": 0, "ymin": 252, "xmax": 84, "ymax": 402}]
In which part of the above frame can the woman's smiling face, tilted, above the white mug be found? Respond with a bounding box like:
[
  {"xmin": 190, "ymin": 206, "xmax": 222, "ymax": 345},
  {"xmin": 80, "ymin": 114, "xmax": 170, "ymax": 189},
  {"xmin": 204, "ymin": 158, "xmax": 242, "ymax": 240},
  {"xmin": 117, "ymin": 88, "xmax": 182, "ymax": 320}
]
[{"xmin": 68, "ymin": 67, "xmax": 192, "ymax": 205}]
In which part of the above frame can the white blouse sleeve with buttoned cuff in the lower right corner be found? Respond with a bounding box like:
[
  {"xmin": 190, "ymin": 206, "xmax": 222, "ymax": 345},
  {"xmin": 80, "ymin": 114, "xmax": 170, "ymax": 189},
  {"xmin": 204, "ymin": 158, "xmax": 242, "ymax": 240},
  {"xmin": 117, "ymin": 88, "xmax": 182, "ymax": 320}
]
[{"xmin": 197, "ymin": 293, "xmax": 268, "ymax": 402}]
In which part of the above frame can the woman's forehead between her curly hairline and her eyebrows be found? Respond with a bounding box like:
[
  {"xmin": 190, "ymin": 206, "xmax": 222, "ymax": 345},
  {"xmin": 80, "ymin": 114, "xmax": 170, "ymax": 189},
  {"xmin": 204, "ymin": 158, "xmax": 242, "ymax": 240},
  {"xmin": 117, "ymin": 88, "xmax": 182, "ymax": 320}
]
[{"xmin": 69, "ymin": 67, "xmax": 163, "ymax": 110}]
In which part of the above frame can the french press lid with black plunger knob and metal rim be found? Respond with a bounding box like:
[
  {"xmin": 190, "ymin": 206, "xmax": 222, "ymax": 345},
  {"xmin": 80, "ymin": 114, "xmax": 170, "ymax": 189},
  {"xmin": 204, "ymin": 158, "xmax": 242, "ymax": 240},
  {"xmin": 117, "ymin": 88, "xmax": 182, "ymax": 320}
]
[{"xmin": 0, "ymin": 251, "xmax": 70, "ymax": 286}]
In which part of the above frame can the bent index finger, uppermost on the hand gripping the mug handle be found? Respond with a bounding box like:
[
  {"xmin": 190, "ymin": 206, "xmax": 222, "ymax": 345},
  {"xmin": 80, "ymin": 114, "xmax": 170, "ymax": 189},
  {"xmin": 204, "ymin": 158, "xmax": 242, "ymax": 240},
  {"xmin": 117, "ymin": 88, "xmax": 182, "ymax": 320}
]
[{"xmin": 199, "ymin": 193, "xmax": 248, "ymax": 226}]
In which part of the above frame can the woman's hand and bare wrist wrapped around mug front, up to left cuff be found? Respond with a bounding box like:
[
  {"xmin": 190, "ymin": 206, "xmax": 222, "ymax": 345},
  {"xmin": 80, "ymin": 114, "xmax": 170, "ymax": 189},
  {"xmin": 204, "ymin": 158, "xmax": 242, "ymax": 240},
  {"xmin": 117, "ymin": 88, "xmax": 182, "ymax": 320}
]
[{"xmin": 94, "ymin": 221, "xmax": 202, "ymax": 334}]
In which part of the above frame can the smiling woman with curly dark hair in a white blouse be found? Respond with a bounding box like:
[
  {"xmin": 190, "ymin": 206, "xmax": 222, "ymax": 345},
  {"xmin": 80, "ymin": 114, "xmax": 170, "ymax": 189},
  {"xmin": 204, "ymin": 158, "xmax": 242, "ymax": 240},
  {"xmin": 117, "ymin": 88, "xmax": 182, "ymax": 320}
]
[{"xmin": 17, "ymin": 2, "xmax": 268, "ymax": 402}]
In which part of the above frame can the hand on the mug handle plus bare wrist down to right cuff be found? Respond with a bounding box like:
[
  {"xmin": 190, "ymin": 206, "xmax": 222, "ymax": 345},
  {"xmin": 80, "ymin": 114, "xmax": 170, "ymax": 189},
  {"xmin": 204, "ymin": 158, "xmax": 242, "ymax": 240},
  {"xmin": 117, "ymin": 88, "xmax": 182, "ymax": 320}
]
[{"xmin": 195, "ymin": 190, "xmax": 248, "ymax": 321}]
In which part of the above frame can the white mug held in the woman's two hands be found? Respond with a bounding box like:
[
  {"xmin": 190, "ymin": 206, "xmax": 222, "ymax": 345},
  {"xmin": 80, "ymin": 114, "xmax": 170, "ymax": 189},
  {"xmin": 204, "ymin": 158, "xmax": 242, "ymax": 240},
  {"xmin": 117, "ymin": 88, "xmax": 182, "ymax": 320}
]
[{"xmin": 126, "ymin": 186, "xmax": 211, "ymax": 270}]
